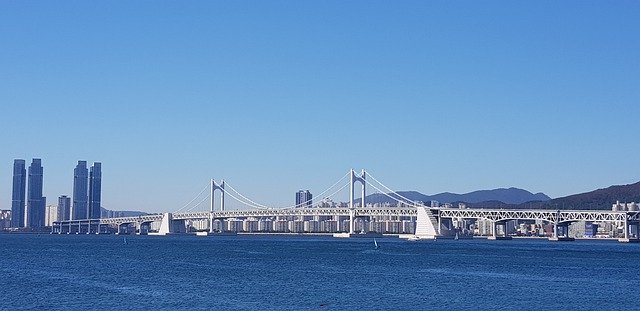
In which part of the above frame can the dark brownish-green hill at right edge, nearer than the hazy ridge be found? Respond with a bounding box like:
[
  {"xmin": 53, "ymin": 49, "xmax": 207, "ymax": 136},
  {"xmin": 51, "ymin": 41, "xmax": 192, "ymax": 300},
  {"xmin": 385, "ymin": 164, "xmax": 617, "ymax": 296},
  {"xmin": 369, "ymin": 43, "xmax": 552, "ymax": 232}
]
[{"xmin": 520, "ymin": 182, "xmax": 640, "ymax": 210}]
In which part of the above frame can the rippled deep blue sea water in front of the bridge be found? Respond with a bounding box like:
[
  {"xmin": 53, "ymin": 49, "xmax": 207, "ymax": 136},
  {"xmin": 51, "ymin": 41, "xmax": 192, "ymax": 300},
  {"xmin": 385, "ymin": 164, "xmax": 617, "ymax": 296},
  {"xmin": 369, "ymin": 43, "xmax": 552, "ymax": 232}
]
[{"xmin": 0, "ymin": 234, "xmax": 640, "ymax": 310}]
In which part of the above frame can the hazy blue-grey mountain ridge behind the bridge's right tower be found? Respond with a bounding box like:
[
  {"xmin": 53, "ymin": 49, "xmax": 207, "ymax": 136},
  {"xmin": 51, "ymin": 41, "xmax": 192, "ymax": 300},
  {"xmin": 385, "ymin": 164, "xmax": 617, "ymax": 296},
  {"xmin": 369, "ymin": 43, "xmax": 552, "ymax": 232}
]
[{"xmin": 356, "ymin": 188, "xmax": 551, "ymax": 205}]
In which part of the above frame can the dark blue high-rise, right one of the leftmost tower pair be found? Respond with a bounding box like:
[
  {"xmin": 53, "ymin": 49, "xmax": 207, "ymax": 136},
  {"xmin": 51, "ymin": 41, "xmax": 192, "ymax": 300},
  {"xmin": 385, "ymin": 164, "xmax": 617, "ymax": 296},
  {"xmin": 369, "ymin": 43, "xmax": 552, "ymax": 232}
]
[{"xmin": 27, "ymin": 159, "xmax": 46, "ymax": 228}]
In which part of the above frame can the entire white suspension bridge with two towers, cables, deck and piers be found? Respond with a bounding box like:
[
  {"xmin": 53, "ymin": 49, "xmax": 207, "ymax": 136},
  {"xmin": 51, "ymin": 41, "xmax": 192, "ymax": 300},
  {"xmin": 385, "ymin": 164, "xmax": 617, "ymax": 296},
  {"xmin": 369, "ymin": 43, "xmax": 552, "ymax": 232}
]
[{"xmin": 52, "ymin": 169, "xmax": 640, "ymax": 242}]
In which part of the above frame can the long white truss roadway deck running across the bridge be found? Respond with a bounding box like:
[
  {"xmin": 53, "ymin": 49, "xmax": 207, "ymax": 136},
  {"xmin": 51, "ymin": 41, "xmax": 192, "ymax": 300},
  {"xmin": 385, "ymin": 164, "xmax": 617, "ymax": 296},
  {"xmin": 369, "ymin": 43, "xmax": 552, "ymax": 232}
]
[{"xmin": 52, "ymin": 207, "xmax": 640, "ymax": 241}]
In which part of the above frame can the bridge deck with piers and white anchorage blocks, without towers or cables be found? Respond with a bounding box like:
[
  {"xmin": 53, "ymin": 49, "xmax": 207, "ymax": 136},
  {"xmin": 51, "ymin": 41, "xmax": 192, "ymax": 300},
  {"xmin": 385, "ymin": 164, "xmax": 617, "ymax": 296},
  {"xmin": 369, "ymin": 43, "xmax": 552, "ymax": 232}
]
[{"xmin": 52, "ymin": 206, "xmax": 640, "ymax": 242}]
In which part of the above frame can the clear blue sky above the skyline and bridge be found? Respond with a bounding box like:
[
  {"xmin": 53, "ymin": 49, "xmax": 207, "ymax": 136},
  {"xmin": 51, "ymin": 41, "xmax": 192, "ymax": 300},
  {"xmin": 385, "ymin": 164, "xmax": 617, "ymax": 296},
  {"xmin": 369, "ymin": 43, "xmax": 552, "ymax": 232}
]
[{"xmin": 0, "ymin": 1, "xmax": 640, "ymax": 212}]
